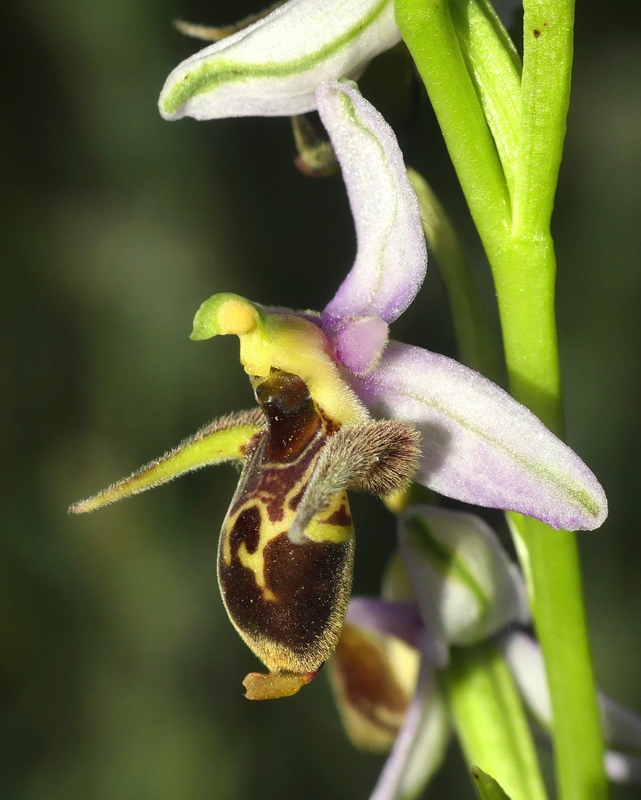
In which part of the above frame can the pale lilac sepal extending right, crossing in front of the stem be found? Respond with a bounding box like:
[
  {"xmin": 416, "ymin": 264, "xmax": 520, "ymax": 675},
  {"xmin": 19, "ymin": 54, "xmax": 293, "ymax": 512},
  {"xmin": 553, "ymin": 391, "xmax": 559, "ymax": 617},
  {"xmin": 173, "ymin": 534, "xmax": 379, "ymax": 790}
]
[{"xmin": 352, "ymin": 342, "xmax": 608, "ymax": 530}]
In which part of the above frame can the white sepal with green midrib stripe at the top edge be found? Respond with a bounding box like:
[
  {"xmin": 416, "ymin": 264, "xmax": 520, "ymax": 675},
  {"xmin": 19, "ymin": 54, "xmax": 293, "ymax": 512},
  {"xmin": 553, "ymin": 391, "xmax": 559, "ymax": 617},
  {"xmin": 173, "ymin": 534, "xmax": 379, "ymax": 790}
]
[{"xmin": 159, "ymin": 0, "xmax": 401, "ymax": 120}]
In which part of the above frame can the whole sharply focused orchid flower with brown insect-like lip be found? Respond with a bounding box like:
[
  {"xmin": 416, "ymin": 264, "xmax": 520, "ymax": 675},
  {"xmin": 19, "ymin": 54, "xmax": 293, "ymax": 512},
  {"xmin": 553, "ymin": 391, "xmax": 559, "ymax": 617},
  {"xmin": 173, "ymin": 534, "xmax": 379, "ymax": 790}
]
[{"xmin": 71, "ymin": 83, "xmax": 607, "ymax": 699}]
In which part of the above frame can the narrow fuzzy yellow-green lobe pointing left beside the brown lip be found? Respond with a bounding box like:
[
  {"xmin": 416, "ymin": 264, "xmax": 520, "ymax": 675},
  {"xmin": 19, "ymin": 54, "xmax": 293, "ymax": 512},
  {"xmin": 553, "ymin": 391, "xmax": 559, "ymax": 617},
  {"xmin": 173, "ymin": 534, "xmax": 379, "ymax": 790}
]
[{"xmin": 69, "ymin": 409, "xmax": 262, "ymax": 514}]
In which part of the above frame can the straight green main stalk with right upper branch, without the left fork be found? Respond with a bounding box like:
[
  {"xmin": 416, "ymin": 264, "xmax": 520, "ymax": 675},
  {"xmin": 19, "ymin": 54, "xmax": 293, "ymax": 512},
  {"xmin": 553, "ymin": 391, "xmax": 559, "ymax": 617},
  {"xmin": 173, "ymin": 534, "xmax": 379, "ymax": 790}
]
[{"xmin": 499, "ymin": 0, "xmax": 608, "ymax": 800}]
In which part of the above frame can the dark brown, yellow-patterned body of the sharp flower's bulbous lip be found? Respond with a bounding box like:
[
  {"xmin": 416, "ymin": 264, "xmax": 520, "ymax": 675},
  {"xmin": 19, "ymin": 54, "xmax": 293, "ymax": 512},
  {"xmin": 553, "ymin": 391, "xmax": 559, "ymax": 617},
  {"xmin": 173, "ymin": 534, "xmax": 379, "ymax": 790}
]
[{"xmin": 218, "ymin": 371, "xmax": 354, "ymax": 674}]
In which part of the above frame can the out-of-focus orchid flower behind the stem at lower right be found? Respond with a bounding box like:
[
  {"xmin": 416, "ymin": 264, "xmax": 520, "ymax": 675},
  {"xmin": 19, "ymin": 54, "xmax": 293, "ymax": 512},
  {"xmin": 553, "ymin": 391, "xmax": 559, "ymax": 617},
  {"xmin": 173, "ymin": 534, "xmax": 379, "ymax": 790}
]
[{"xmin": 329, "ymin": 506, "xmax": 641, "ymax": 800}]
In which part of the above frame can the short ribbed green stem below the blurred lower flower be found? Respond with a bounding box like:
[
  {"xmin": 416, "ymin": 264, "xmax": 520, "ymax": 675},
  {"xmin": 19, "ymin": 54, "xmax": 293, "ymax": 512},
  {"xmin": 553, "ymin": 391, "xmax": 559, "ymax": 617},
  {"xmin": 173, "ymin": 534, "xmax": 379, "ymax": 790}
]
[{"xmin": 444, "ymin": 642, "xmax": 546, "ymax": 800}]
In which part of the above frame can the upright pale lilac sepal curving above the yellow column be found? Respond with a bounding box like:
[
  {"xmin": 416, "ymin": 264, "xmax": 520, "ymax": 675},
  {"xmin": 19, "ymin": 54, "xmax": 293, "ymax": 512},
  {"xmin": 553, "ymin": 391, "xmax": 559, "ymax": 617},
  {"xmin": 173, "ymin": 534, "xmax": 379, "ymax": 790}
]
[{"xmin": 316, "ymin": 81, "xmax": 427, "ymax": 328}]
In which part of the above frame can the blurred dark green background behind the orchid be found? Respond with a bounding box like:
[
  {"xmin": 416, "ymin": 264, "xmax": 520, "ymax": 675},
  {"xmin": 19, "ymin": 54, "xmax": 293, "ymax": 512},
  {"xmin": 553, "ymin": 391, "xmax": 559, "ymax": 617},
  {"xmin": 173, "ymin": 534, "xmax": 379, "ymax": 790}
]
[{"xmin": 0, "ymin": 0, "xmax": 641, "ymax": 800}]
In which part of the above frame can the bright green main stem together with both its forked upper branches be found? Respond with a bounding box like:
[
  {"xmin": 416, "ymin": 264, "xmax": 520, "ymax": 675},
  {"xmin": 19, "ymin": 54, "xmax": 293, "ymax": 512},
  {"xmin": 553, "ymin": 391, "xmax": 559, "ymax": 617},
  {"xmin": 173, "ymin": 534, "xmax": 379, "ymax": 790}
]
[{"xmin": 396, "ymin": 0, "xmax": 608, "ymax": 800}]
